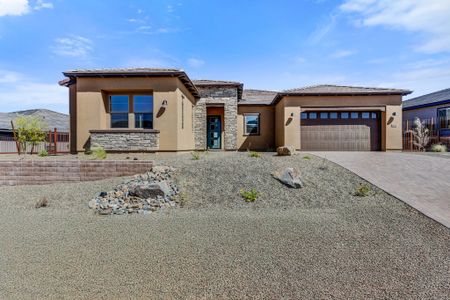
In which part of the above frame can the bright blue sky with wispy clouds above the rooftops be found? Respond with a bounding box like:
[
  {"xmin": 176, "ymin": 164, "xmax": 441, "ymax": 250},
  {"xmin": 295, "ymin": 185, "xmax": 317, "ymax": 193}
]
[{"xmin": 0, "ymin": 0, "xmax": 450, "ymax": 113}]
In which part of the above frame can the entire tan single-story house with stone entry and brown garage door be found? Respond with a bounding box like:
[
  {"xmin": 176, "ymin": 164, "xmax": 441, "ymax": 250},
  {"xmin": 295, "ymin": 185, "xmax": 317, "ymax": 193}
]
[{"xmin": 60, "ymin": 68, "xmax": 411, "ymax": 153}]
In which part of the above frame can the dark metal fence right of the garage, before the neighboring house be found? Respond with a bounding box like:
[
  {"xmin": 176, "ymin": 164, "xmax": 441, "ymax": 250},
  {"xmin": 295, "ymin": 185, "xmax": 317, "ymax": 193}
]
[{"xmin": 403, "ymin": 118, "xmax": 450, "ymax": 151}]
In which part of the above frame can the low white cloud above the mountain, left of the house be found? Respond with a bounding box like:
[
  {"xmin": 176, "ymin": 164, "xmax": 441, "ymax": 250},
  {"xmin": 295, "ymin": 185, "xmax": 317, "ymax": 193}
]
[{"xmin": 0, "ymin": 70, "xmax": 68, "ymax": 111}]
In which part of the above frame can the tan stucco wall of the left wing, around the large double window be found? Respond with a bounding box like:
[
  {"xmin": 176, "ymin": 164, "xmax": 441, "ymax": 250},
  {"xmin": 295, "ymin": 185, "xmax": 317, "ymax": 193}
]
[{"xmin": 77, "ymin": 77, "xmax": 195, "ymax": 151}]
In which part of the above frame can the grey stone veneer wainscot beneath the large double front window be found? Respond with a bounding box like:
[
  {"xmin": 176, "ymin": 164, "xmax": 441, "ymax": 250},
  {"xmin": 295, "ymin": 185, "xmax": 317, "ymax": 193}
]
[{"xmin": 90, "ymin": 129, "xmax": 159, "ymax": 152}]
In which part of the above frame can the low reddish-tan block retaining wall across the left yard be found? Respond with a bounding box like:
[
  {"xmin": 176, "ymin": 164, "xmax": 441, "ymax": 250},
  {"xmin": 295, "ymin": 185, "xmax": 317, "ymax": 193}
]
[{"xmin": 0, "ymin": 160, "xmax": 153, "ymax": 186}]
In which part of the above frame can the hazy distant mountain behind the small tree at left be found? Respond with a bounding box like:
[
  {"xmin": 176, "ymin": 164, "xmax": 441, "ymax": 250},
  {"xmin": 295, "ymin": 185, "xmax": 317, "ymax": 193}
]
[{"xmin": 0, "ymin": 109, "xmax": 69, "ymax": 132}]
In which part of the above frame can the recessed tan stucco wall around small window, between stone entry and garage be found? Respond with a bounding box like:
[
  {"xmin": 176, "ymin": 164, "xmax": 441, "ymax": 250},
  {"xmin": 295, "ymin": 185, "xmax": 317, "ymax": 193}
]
[{"xmin": 237, "ymin": 105, "xmax": 275, "ymax": 150}]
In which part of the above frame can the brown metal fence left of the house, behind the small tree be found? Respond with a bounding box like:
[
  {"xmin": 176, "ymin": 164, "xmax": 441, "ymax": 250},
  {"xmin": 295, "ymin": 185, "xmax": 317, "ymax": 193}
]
[{"xmin": 0, "ymin": 130, "xmax": 70, "ymax": 154}]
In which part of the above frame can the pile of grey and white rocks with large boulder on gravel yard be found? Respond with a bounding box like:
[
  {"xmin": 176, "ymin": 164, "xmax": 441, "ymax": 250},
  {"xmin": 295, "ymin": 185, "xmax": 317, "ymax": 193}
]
[{"xmin": 89, "ymin": 166, "xmax": 179, "ymax": 215}]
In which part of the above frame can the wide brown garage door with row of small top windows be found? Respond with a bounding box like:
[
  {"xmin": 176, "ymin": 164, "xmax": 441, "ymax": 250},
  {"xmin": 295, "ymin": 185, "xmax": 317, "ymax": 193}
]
[{"xmin": 300, "ymin": 111, "xmax": 381, "ymax": 151}]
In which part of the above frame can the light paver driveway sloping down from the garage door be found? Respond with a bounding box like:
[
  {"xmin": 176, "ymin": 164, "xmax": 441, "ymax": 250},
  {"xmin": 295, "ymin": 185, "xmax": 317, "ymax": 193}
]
[{"xmin": 311, "ymin": 152, "xmax": 450, "ymax": 228}]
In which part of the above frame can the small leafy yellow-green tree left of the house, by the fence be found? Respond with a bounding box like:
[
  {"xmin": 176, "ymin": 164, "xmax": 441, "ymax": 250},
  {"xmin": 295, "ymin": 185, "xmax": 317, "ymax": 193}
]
[{"xmin": 15, "ymin": 116, "xmax": 48, "ymax": 154}]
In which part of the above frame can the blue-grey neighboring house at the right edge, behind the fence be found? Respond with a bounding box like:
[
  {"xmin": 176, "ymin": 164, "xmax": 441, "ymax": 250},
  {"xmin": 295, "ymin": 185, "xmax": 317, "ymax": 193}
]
[{"xmin": 403, "ymin": 89, "xmax": 450, "ymax": 137}]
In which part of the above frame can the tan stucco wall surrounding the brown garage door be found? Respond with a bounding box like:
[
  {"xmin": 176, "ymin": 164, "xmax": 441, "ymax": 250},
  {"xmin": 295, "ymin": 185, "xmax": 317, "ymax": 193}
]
[{"xmin": 275, "ymin": 95, "xmax": 402, "ymax": 150}]
